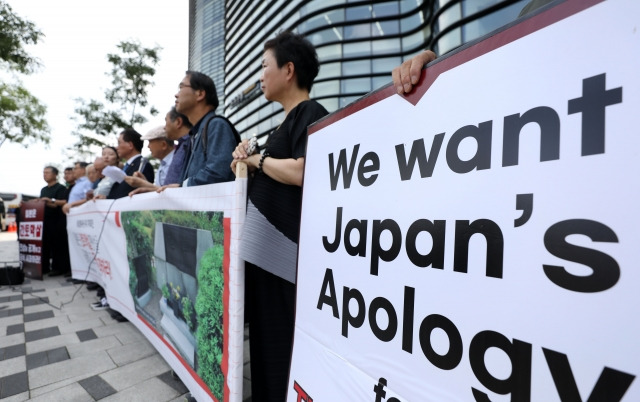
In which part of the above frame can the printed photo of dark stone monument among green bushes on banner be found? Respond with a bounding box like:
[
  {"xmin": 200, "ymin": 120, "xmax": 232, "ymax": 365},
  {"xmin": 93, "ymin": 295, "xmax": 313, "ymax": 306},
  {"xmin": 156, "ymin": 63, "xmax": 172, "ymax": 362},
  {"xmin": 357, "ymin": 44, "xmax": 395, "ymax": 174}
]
[{"xmin": 122, "ymin": 210, "xmax": 224, "ymax": 395}]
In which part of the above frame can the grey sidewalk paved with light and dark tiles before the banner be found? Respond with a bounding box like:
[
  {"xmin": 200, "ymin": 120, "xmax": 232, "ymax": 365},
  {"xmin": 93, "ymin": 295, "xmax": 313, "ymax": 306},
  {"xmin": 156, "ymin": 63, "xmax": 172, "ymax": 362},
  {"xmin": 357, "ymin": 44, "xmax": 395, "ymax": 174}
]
[{"xmin": 0, "ymin": 232, "xmax": 251, "ymax": 402}]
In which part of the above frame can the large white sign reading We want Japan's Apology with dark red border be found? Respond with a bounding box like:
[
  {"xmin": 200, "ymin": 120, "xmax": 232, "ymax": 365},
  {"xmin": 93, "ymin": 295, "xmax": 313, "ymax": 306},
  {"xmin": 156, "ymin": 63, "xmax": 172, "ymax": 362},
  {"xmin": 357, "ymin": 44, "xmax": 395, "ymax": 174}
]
[{"xmin": 287, "ymin": 0, "xmax": 640, "ymax": 402}]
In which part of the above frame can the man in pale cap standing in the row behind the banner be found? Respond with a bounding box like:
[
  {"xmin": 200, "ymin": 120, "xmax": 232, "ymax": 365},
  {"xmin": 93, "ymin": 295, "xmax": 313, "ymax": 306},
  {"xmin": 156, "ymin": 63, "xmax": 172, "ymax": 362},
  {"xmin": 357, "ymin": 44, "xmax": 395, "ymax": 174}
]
[{"xmin": 125, "ymin": 126, "xmax": 175, "ymax": 189}]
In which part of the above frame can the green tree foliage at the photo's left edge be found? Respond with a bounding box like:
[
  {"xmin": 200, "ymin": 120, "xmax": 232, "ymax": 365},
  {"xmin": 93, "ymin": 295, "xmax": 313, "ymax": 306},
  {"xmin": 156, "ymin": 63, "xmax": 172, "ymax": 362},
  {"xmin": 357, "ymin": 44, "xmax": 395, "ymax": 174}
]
[{"xmin": 0, "ymin": 0, "xmax": 49, "ymax": 147}]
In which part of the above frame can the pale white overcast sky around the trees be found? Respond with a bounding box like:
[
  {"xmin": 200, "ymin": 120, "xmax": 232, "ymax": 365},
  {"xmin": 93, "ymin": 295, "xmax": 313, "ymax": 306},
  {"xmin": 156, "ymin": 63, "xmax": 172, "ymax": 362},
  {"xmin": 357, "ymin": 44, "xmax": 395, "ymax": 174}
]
[{"xmin": 0, "ymin": 0, "xmax": 189, "ymax": 195}]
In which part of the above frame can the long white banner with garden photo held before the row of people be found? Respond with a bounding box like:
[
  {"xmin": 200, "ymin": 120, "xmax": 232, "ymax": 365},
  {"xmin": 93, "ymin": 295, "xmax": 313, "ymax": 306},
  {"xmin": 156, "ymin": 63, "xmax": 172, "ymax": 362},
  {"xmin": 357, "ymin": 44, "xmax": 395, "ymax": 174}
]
[{"xmin": 67, "ymin": 178, "xmax": 247, "ymax": 401}]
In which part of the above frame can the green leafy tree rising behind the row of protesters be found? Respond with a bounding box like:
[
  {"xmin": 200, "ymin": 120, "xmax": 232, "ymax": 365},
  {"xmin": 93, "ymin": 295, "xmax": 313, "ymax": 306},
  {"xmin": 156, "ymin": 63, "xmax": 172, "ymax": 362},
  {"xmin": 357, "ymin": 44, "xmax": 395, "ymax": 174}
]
[{"xmin": 72, "ymin": 41, "xmax": 162, "ymax": 155}]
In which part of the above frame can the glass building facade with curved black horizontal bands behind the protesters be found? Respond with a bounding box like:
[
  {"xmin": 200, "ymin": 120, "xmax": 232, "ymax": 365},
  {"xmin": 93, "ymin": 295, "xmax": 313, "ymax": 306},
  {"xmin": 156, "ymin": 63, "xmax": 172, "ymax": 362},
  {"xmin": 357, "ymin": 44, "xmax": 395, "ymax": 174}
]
[{"xmin": 189, "ymin": 0, "xmax": 527, "ymax": 140}]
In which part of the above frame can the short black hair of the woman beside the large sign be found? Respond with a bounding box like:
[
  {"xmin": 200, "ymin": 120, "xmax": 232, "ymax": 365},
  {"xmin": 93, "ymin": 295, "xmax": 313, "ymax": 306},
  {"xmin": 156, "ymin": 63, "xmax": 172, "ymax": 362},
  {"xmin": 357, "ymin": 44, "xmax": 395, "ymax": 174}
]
[{"xmin": 264, "ymin": 31, "xmax": 320, "ymax": 91}]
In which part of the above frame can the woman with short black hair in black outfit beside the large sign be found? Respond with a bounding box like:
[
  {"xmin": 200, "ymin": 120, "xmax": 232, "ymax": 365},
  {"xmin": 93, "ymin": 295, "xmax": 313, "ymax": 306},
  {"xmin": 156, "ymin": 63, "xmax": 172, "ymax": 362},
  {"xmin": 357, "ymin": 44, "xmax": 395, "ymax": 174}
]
[{"xmin": 231, "ymin": 32, "xmax": 328, "ymax": 402}]
